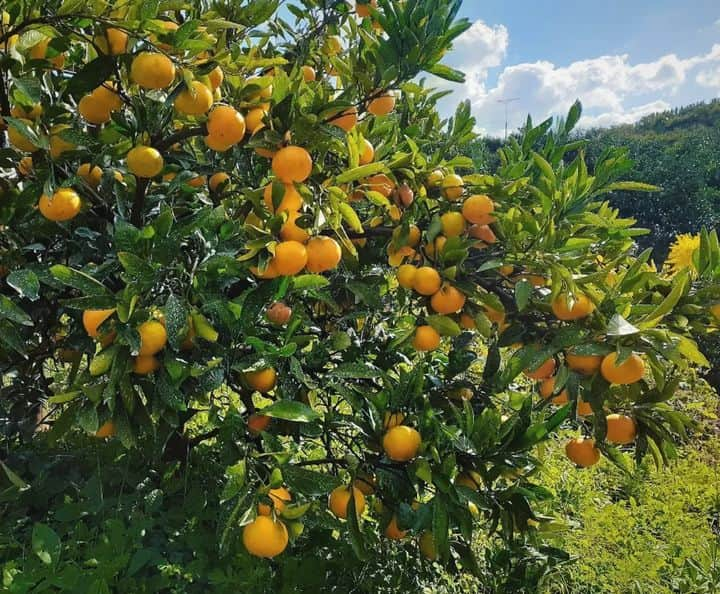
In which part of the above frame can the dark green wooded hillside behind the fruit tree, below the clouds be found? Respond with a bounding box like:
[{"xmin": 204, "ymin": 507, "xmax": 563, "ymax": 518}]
[{"xmin": 584, "ymin": 100, "xmax": 720, "ymax": 263}]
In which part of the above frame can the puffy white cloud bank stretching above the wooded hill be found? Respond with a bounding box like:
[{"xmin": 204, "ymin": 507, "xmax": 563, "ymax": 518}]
[{"xmin": 431, "ymin": 21, "xmax": 720, "ymax": 134}]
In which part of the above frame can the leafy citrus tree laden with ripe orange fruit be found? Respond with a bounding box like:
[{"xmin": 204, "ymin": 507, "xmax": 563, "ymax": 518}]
[{"xmin": 0, "ymin": 0, "xmax": 720, "ymax": 592}]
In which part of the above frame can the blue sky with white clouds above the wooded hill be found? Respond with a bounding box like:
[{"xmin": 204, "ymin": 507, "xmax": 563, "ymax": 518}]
[{"xmin": 434, "ymin": 0, "xmax": 720, "ymax": 134}]
